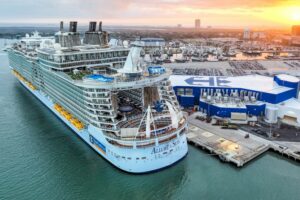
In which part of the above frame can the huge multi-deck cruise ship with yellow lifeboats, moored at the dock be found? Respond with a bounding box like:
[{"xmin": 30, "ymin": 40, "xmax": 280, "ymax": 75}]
[{"xmin": 7, "ymin": 21, "xmax": 188, "ymax": 173}]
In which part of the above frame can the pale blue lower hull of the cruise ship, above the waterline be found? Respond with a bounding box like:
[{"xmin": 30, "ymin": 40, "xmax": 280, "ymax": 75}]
[{"xmin": 20, "ymin": 76, "xmax": 188, "ymax": 173}]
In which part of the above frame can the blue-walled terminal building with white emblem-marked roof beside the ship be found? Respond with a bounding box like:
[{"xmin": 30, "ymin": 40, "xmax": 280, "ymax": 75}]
[{"xmin": 170, "ymin": 74, "xmax": 300, "ymax": 126}]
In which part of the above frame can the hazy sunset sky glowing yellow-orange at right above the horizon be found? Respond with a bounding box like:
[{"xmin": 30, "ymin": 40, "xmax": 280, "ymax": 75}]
[{"xmin": 0, "ymin": 0, "xmax": 300, "ymax": 27}]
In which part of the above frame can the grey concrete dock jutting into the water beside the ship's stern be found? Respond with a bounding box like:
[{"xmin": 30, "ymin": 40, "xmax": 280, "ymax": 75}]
[{"xmin": 187, "ymin": 114, "xmax": 300, "ymax": 167}]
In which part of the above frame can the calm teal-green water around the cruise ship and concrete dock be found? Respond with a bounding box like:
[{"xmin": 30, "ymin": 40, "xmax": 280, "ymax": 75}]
[{"xmin": 0, "ymin": 40, "xmax": 300, "ymax": 200}]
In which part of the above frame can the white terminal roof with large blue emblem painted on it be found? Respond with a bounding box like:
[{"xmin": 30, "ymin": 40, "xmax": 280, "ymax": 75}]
[{"xmin": 170, "ymin": 75, "xmax": 299, "ymax": 94}]
